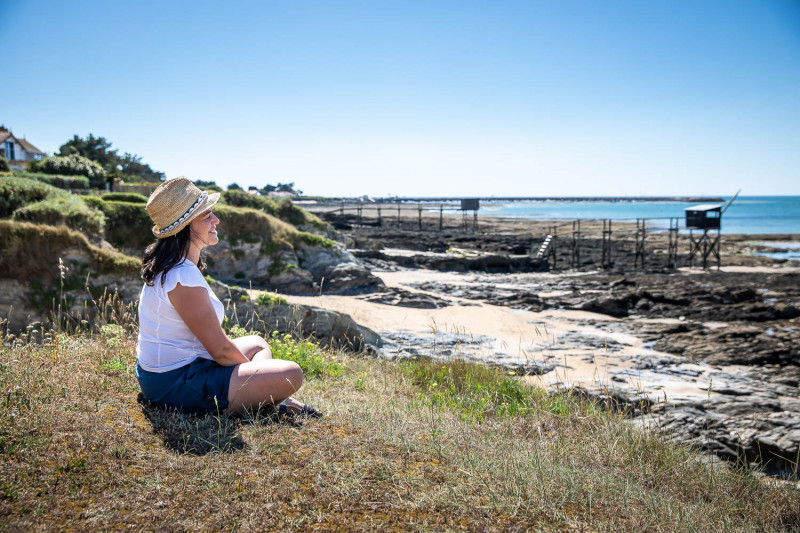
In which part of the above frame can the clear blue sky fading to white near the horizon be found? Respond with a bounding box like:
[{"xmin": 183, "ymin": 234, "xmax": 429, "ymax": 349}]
[{"xmin": 0, "ymin": 0, "xmax": 800, "ymax": 196}]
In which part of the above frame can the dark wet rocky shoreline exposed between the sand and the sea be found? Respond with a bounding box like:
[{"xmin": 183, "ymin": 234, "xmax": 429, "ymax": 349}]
[{"xmin": 300, "ymin": 208, "xmax": 800, "ymax": 476}]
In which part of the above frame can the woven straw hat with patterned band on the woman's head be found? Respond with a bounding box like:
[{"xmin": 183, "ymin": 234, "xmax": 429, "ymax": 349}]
[{"xmin": 145, "ymin": 178, "xmax": 219, "ymax": 239}]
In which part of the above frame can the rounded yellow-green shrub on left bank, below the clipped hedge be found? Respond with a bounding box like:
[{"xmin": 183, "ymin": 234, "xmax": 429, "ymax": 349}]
[{"xmin": 13, "ymin": 194, "xmax": 106, "ymax": 236}]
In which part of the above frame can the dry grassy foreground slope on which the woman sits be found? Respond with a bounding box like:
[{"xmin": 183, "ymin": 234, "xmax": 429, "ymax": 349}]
[{"xmin": 0, "ymin": 318, "xmax": 800, "ymax": 532}]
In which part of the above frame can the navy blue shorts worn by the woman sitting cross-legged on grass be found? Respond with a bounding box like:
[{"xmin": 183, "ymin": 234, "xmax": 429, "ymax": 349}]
[{"xmin": 136, "ymin": 357, "xmax": 236, "ymax": 414}]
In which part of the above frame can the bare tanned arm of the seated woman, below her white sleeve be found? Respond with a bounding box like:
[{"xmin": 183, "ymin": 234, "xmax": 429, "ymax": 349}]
[{"xmin": 169, "ymin": 283, "xmax": 248, "ymax": 366}]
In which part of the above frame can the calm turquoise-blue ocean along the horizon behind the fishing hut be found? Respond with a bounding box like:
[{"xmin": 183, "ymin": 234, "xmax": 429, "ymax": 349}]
[{"xmin": 478, "ymin": 196, "xmax": 800, "ymax": 235}]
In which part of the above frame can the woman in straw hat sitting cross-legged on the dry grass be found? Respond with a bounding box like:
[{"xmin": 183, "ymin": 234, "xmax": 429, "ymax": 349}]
[{"xmin": 136, "ymin": 178, "xmax": 321, "ymax": 417}]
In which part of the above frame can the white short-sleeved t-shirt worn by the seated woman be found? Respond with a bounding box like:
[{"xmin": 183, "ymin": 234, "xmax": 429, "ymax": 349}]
[{"xmin": 136, "ymin": 259, "xmax": 225, "ymax": 372}]
